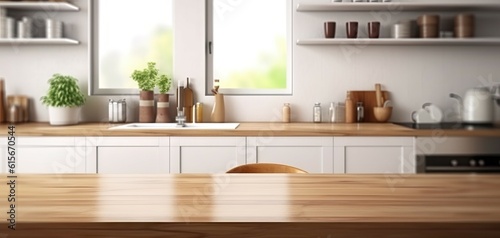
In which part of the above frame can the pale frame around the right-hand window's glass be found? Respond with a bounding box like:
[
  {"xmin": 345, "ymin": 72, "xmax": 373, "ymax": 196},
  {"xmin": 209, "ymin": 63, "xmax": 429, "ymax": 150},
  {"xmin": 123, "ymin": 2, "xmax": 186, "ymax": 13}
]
[{"xmin": 205, "ymin": 0, "xmax": 293, "ymax": 96}]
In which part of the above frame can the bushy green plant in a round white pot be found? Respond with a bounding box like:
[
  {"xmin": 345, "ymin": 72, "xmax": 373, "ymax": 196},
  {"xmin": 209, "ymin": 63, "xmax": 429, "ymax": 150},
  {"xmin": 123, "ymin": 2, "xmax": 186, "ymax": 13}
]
[{"xmin": 40, "ymin": 74, "xmax": 86, "ymax": 125}]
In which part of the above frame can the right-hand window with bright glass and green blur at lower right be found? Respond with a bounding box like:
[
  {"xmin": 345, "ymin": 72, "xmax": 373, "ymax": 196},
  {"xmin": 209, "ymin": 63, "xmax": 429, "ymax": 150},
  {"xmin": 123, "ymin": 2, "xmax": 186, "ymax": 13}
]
[{"xmin": 207, "ymin": 0, "xmax": 292, "ymax": 94}]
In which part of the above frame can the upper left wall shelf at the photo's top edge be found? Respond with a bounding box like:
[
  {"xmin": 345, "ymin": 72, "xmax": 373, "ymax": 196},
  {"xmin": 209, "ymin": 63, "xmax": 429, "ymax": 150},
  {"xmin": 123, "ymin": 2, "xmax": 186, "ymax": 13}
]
[{"xmin": 0, "ymin": 2, "xmax": 80, "ymax": 11}]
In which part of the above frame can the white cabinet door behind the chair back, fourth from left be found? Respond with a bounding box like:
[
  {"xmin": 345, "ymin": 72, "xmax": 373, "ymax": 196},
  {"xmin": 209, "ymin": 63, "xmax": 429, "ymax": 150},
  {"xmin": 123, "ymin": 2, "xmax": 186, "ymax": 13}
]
[{"xmin": 247, "ymin": 137, "xmax": 333, "ymax": 173}]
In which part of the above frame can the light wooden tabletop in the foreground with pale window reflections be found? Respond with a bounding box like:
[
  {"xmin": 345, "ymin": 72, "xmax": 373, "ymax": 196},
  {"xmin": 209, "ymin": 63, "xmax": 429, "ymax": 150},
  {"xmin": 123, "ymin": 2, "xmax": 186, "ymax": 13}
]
[{"xmin": 0, "ymin": 174, "xmax": 500, "ymax": 238}]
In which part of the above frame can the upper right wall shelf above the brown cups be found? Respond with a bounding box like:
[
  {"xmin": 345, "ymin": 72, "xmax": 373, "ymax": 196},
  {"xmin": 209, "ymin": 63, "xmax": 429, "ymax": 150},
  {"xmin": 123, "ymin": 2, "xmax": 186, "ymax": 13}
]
[{"xmin": 297, "ymin": 2, "xmax": 500, "ymax": 12}]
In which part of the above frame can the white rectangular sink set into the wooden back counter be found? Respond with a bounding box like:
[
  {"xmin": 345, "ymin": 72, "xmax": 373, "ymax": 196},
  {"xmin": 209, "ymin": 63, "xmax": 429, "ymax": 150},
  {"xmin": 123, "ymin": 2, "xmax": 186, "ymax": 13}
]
[{"xmin": 109, "ymin": 123, "xmax": 240, "ymax": 130}]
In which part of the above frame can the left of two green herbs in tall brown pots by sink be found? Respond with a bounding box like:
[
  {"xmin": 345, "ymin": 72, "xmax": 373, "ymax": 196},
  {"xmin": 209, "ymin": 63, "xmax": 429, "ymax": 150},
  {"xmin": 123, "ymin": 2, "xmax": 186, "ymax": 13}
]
[{"xmin": 131, "ymin": 62, "xmax": 168, "ymax": 123}]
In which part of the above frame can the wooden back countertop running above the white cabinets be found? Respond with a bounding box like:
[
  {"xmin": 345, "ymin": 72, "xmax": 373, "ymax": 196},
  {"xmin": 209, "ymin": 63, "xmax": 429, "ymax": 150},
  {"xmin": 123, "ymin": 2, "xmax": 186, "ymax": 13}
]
[{"xmin": 0, "ymin": 122, "xmax": 500, "ymax": 137}]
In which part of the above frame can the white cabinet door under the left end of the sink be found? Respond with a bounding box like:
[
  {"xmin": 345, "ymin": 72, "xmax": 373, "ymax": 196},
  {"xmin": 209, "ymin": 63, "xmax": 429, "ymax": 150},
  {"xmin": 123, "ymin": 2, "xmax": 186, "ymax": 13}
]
[{"xmin": 87, "ymin": 137, "xmax": 170, "ymax": 174}]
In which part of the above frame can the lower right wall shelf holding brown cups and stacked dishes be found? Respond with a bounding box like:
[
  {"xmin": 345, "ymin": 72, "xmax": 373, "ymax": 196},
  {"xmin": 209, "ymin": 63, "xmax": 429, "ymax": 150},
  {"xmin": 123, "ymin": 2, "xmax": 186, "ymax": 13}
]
[{"xmin": 297, "ymin": 38, "xmax": 500, "ymax": 46}]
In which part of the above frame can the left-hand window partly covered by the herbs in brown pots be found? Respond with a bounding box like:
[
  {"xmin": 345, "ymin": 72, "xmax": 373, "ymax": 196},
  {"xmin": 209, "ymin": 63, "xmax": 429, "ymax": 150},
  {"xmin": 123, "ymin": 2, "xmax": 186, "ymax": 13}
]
[{"xmin": 89, "ymin": 0, "xmax": 173, "ymax": 95}]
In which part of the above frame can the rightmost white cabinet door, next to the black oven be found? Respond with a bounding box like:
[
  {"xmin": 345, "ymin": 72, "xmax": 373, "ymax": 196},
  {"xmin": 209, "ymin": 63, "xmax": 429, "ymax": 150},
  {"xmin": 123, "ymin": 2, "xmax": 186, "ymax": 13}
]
[{"xmin": 334, "ymin": 137, "xmax": 416, "ymax": 174}]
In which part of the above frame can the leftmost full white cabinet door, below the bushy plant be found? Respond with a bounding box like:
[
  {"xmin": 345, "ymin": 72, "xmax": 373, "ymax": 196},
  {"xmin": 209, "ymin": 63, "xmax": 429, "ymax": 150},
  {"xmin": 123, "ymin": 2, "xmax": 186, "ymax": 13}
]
[{"xmin": 8, "ymin": 137, "xmax": 87, "ymax": 174}]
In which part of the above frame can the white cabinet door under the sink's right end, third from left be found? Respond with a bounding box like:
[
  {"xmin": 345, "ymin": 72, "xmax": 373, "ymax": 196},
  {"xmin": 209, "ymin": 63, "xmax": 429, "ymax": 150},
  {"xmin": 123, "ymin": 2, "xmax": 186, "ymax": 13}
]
[{"xmin": 170, "ymin": 137, "xmax": 246, "ymax": 173}]
